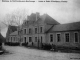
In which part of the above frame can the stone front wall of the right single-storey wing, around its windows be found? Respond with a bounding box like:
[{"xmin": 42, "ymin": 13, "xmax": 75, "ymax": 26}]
[{"xmin": 46, "ymin": 31, "xmax": 80, "ymax": 47}]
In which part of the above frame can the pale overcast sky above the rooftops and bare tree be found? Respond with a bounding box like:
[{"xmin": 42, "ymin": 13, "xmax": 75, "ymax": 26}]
[{"xmin": 0, "ymin": 0, "xmax": 80, "ymax": 37}]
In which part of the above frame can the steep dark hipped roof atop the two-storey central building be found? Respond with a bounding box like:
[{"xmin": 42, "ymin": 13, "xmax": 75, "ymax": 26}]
[{"xmin": 25, "ymin": 13, "xmax": 60, "ymax": 25}]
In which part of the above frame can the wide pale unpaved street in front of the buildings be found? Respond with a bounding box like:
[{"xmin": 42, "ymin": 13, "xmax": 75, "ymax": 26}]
[{"xmin": 0, "ymin": 46, "xmax": 80, "ymax": 60}]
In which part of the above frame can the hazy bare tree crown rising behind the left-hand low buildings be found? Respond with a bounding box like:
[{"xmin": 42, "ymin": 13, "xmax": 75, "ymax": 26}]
[{"xmin": 2, "ymin": 9, "xmax": 28, "ymax": 26}]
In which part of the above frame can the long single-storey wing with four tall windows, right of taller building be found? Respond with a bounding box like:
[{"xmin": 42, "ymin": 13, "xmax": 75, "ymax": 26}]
[{"xmin": 46, "ymin": 22, "xmax": 80, "ymax": 48}]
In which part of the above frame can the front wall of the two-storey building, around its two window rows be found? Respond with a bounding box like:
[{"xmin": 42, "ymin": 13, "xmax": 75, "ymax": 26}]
[{"xmin": 22, "ymin": 21, "xmax": 45, "ymax": 47}]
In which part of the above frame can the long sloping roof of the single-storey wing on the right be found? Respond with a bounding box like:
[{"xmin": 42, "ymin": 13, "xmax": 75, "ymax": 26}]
[{"xmin": 48, "ymin": 22, "xmax": 80, "ymax": 32}]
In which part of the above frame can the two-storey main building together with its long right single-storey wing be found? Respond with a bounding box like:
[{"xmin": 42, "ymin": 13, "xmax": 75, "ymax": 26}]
[{"xmin": 6, "ymin": 13, "xmax": 80, "ymax": 48}]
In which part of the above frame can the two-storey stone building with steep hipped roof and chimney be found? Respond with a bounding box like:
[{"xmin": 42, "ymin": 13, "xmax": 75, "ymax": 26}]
[{"xmin": 21, "ymin": 13, "xmax": 59, "ymax": 47}]
